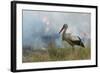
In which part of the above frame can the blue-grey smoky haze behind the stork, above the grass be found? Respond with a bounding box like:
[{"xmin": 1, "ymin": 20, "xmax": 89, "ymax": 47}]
[{"xmin": 22, "ymin": 10, "xmax": 91, "ymax": 48}]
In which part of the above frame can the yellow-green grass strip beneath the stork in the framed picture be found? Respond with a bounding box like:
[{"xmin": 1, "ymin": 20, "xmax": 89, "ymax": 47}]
[{"xmin": 22, "ymin": 48, "xmax": 91, "ymax": 63}]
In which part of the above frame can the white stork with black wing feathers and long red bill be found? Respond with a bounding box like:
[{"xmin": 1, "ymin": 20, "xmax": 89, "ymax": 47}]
[{"xmin": 59, "ymin": 24, "xmax": 85, "ymax": 49}]
